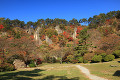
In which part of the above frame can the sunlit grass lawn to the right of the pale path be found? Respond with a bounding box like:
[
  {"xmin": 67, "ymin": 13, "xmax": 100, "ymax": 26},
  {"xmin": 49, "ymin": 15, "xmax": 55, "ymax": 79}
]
[{"xmin": 82, "ymin": 58, "xmax": 120, "ymax": 80}]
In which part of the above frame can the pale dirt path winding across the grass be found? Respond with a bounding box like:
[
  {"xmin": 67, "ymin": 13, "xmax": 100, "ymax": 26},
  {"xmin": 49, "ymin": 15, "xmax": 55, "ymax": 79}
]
[{"xmin": 75, "ymin": 65, "xmax": 108, "ymax": 80}]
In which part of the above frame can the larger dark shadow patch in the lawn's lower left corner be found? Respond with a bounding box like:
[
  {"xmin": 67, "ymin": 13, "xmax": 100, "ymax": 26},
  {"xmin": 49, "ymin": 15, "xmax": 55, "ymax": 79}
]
[{"xmin": 0, "ymin": 69, "xmax": 44, "ymax": 80}]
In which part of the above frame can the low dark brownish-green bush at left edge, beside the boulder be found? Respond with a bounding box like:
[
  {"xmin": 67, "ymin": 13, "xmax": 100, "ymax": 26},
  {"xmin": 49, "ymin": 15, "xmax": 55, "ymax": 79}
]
[{"xmin": 0, "ymin": 63, "xmax": 15, "ymax": 72}]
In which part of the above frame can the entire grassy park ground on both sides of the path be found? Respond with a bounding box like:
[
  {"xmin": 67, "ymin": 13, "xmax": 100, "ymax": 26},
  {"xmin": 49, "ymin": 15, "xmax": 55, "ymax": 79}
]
[{"xmin": 0, "ymin": 58, "xmax": 120, "ymax": 80}]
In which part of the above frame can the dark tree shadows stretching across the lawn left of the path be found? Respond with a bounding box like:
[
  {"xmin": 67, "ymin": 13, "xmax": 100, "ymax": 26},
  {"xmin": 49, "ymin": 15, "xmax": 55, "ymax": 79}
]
[{"xmin": 0, "ymin": 69, "xmax": 80, "ymax": 80}]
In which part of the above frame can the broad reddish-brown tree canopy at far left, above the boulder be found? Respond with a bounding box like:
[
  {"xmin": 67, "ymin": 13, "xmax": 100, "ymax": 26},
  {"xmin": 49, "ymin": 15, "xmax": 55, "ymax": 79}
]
[{"xmin": 0, "ymin": 36, "xmax": 36, "ymax": 61}]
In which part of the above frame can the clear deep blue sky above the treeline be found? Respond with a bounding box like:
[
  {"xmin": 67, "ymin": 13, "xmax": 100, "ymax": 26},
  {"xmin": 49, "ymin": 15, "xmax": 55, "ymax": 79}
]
[{"xmin": 0, "ymin": 0, "xmax": 120, "ymax": 22}]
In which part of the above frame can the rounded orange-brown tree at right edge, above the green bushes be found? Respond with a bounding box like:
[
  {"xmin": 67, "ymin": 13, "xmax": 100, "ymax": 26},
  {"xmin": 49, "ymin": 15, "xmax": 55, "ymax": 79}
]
[{"xmin": 97, "ymin": 34, "xmax": 120, "ymax": 54}]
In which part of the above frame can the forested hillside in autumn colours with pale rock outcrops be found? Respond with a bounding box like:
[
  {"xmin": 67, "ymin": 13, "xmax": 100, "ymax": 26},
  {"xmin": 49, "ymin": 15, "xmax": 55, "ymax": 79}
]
[{"xmin": 0, "ymin": 11, "xmax": 120, "ymax": 71}]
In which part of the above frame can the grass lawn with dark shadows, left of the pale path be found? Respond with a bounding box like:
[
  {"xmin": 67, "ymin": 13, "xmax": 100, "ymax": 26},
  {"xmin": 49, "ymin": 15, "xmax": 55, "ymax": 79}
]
[{"xmin": 0, "ymin": 64, "xmax": 89, "ymax": 80}]
